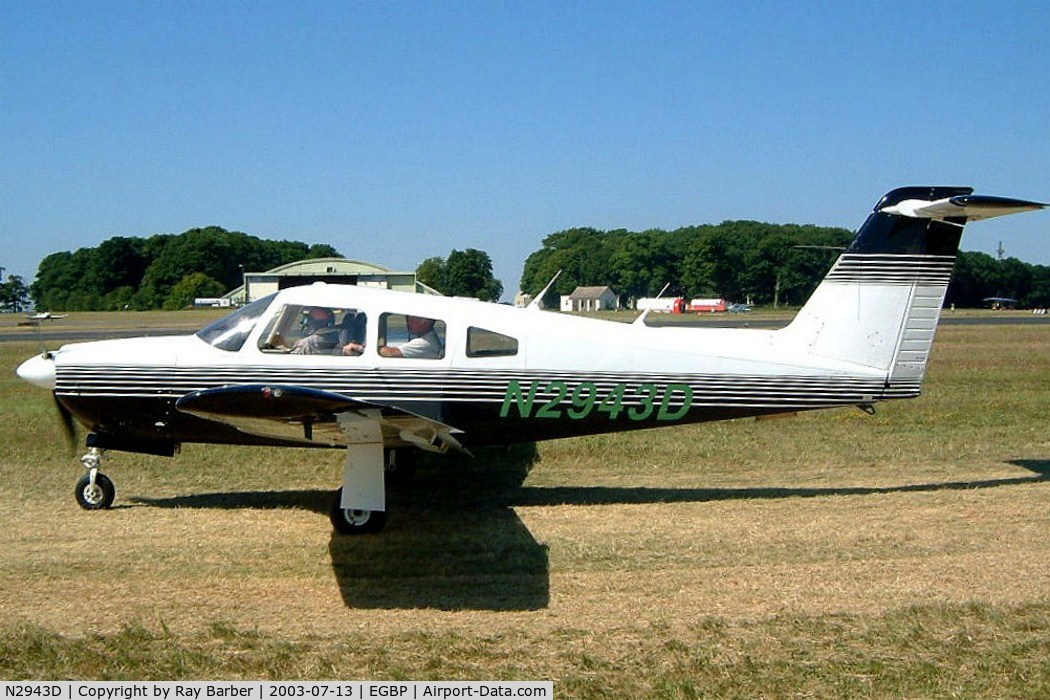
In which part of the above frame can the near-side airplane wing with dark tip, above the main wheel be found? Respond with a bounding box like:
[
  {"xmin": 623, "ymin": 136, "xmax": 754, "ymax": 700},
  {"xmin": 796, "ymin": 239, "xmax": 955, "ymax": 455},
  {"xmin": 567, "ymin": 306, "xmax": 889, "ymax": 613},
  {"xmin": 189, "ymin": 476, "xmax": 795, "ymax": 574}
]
[{"xmin": 175, "ymin": 384, "xmax": 466, "ymax": 452}]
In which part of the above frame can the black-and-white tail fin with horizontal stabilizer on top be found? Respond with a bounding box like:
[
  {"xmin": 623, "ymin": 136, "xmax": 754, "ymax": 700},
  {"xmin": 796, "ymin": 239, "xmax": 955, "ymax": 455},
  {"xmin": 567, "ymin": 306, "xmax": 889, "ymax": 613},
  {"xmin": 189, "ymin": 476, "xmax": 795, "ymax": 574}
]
[{"xmin": 783, "ymin": 187, "xmax": 1047, "ymax": 396}]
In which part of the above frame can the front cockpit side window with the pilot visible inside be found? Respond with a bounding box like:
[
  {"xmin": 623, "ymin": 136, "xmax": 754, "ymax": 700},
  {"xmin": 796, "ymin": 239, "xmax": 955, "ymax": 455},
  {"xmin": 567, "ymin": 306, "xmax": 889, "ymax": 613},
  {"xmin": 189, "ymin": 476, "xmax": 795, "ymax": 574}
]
[{"xmin": 259, "ymin": 304, "xmax": 368, "ymax": 356}]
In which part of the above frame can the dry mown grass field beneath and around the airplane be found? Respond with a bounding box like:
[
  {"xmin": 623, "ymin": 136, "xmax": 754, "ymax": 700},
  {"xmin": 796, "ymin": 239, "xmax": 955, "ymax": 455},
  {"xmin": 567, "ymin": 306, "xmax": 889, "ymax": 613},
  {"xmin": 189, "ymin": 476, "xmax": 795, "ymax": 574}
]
[{"xmin": 0, "ymin": 325, "xmax": 1050, "ymax": 698}]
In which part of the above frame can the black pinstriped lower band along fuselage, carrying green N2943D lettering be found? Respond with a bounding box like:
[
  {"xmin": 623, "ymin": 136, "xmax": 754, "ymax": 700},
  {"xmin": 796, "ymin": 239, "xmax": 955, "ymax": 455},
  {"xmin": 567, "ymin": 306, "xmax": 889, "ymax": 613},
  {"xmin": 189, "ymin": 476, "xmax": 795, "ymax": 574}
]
[{"xmin": 56, "ymin": 366, "xmax": 920, "ymax": 445}]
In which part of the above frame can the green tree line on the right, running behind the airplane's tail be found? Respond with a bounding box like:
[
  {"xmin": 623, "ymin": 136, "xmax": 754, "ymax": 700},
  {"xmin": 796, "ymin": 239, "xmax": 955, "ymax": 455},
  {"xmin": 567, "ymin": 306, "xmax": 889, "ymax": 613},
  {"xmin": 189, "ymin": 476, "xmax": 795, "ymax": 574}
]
[{"xmin": 521, "ymin": 220, "xmax": 1050, "ymax": 307}]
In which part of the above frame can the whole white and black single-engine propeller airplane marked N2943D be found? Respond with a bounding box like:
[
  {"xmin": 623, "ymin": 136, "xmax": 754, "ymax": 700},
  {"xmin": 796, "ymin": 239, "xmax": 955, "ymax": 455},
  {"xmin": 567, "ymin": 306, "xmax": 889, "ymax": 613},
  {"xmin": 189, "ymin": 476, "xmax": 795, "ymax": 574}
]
[{"xmin": 18, "ymin": 187, "xmax": 1047, "ymax": 533}]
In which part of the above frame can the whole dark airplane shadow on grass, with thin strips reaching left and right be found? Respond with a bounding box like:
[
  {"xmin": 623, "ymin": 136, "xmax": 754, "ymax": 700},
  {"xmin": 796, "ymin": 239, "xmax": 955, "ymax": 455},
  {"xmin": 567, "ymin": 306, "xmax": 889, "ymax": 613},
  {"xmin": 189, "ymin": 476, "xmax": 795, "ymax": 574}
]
[{"xmin": 132, "ymin": 445, "xmax": 1050, "ymax": 611}]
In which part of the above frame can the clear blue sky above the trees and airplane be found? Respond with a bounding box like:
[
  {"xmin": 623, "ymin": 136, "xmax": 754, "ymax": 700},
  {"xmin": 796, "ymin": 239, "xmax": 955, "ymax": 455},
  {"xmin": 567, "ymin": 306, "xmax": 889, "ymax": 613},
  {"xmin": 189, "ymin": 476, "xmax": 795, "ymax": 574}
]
[{"xmin": 0, "ymin": 0, "xmax": 1050, "ymax": 296}]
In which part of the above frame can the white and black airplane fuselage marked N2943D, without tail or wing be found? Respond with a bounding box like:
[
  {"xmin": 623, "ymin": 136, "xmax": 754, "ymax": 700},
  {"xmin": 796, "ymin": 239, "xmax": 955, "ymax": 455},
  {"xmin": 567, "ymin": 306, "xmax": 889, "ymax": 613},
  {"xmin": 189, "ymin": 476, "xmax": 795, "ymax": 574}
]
[{"xmin": 40, "ymin": 284, "xmax": 918, "ymax": 452}]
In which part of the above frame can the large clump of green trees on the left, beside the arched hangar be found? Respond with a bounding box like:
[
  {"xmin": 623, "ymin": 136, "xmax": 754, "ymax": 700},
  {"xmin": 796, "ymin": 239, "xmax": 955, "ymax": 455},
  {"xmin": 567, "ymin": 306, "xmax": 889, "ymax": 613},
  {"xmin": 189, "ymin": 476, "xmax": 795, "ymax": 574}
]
[{"xmin": 29, "ymin": 227, "xmax": 341, "ymax": 311}]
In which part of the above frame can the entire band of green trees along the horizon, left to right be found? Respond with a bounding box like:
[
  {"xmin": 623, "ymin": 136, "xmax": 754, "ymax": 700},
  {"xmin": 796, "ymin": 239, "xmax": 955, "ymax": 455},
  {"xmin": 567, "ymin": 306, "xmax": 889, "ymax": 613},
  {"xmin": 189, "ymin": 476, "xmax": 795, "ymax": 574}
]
[{"xmin": 10, "ymin": 220, "xmax": 1050, "ymax": 311}]
